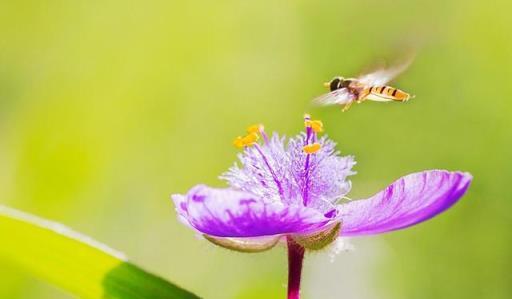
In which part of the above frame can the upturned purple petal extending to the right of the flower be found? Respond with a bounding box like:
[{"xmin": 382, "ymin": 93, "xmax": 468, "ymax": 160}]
[{"xmin": 339, "ymin": 170, "xmax": 472, "ymax": 236}]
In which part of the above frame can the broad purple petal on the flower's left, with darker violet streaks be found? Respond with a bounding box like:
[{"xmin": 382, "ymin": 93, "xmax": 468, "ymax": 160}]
[{"xmin": 172, "ymin": 185, "xmax": 334, "ymax": 237}]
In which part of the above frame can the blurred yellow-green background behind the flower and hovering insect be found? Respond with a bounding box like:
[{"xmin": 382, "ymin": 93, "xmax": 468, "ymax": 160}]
[{"xmin": 0, "ymin": 0, "xmax": 512, "ymax": 299}]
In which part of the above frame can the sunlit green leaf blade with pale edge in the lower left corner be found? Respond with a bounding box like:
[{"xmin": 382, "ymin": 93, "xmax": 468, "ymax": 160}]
[{"xmin": 0, "ymin": 205, "xmax": 199, "ymax": 299}]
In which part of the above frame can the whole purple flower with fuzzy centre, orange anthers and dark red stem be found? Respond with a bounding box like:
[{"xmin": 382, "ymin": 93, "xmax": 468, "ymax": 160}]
[{"xmin": 172, "ymin": 115, "xmax": 472, "ymax": 298}]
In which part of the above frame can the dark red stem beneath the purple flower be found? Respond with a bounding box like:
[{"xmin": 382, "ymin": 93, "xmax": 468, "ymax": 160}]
[{"xmin": 287, "ymin": 237, "xmax": 304, "ymax": 299}]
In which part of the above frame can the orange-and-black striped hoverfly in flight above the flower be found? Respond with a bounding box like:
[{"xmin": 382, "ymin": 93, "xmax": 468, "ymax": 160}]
[{"xmin": 313, "ymin": 59, "xmax": 414, "ymax": 112}]
